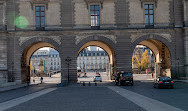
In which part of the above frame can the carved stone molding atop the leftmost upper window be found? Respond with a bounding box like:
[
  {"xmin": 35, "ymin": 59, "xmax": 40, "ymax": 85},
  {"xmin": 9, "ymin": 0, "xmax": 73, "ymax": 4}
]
[{"xmin": 30, "ymin": 0, "xmax": 49, "ymax": 10}]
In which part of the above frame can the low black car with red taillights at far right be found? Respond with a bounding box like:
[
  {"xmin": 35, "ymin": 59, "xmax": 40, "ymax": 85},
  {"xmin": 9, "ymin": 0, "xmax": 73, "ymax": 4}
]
[{"xmin": 153, "ymin": 77, "xmax": 174, "ymax": 89}]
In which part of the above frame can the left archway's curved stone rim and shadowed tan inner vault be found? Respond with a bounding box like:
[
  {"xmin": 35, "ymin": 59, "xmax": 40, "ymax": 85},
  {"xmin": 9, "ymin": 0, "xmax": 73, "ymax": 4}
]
[{"xmin": 20, "ymin": 38, "xmax": 61, "ymax": 83}]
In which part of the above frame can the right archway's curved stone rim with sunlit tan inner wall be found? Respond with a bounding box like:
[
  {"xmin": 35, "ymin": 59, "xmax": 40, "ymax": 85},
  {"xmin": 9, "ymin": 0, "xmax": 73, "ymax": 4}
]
[{"xmin": 133, "ymin": 36, "xmax": 173, "ymax": 77}]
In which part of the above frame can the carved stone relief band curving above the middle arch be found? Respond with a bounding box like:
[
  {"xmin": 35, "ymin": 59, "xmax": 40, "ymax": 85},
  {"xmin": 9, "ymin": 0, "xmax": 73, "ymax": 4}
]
[{"xmin": 75, "ymin": 34, "xmax": 117, "ymax": 45}]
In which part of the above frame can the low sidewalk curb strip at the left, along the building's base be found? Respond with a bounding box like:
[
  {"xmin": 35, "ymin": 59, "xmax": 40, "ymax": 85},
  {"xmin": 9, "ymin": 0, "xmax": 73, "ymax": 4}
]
[{"xmin": 0, "ymin": 84, "xmax": 39, "ymax": 93}]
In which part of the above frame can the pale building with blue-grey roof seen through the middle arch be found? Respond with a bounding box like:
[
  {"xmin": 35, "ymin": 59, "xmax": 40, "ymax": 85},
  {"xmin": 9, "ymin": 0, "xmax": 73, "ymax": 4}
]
[{"xmin": 77, "ymin": 46, "xmax": 109, "ymax": 72}]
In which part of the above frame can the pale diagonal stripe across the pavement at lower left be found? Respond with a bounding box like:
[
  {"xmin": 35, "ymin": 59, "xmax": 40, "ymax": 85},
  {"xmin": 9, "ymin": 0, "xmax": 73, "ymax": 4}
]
[{"xmin": 0, "ymin": 88, "xmax": 57, "ymax": 111}]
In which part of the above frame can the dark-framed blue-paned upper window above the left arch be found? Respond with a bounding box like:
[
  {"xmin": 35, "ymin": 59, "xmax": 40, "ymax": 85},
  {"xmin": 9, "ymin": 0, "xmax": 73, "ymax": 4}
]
[{"xmin": 35, "ymin": 6, "xmax": 45, "ymax": 30}]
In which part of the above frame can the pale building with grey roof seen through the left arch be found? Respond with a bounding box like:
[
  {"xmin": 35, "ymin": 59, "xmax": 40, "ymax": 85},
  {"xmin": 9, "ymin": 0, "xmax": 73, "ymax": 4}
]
[{"xmin": 31, "ymin": 48, "xmax": 61, "ymax": 73}]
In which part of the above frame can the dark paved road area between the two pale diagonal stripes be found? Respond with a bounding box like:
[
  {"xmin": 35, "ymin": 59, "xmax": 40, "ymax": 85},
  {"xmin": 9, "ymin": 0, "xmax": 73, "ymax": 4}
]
[{"xmin": 4, "ymin": 87, "xmax": 144, "ymax": 111}]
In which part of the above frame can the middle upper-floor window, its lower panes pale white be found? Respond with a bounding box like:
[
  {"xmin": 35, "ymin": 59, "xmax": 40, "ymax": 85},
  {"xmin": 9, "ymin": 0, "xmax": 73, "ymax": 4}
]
[{"xmin": 90, "ymin": 5, "xmax": 100, "ymax": 29}]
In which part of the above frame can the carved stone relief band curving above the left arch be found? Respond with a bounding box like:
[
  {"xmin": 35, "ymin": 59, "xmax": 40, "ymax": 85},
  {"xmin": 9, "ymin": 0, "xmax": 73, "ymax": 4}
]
[{"xmin": 19, "ymin": 36, "xmax": 61, "ymax": 46}]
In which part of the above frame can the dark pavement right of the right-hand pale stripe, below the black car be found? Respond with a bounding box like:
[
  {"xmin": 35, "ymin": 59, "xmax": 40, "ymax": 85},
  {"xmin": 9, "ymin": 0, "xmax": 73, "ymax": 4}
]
[{"xmin": 121, "ymin": 81, "xmax": 188, "ymax": 111}]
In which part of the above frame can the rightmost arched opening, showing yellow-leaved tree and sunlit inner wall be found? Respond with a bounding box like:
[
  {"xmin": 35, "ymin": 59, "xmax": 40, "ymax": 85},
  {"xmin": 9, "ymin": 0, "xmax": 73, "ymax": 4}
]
[{"xmin": 132, "ymin": 39, "xmax": 171, "ymax": 79}]
